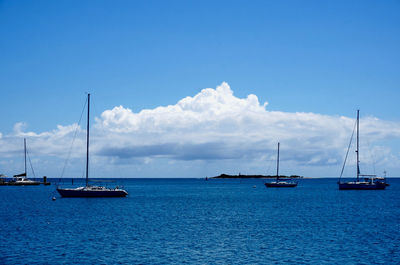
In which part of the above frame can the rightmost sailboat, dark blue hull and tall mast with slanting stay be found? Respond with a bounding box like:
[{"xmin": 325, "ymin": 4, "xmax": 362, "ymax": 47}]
[{"xmin": 338, "ymin": 110, "xmax": 388, "ymax": 190}]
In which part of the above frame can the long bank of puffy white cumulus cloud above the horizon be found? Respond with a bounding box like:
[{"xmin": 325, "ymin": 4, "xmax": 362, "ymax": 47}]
[{"xmin": 0, "ymin": 82, "xmax": 400, "ymax": 175}]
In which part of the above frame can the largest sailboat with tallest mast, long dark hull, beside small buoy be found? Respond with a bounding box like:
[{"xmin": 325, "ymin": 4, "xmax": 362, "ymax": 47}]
[{"xmin": 57, "ymin": 94, "xmax": 128, "ymax": 197}]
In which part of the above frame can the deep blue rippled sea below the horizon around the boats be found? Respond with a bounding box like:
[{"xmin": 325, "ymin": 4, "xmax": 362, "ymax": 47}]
[{"xmin": 0, "ymin": 179, "xmax": 400, "ymax": 264}]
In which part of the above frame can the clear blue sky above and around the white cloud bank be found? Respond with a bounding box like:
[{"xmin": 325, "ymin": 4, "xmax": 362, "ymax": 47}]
[{"xmin": 0, "ymin": 1, "xmax": 400, "ymax": 176}]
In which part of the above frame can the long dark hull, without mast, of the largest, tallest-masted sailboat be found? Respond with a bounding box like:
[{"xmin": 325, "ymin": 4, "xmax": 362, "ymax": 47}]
[{"xmin": 57, "ymin": 186, "xmax": 128, "ymax": 198}]
